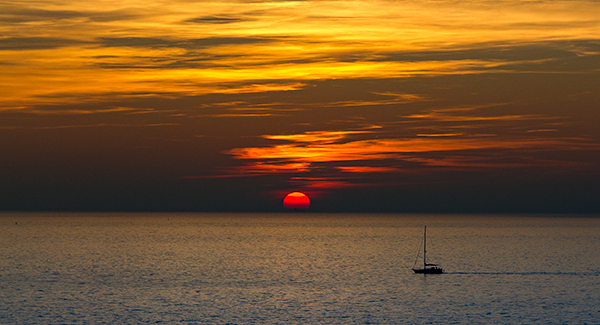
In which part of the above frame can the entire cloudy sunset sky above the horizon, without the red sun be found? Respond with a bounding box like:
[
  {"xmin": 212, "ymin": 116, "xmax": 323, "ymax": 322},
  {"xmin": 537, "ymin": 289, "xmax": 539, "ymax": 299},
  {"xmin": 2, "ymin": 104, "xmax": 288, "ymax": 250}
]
[{"xmin": 0, "ymin": 0, "xmax": 600, "ymax": 213}]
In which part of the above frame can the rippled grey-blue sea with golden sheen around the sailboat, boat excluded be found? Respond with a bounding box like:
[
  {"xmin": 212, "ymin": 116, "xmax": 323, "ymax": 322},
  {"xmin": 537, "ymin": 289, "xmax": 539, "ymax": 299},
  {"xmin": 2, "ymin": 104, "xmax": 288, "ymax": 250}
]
[{"xmin": 0, "ymin": 213, "xmax": 600, "ymax": 324}]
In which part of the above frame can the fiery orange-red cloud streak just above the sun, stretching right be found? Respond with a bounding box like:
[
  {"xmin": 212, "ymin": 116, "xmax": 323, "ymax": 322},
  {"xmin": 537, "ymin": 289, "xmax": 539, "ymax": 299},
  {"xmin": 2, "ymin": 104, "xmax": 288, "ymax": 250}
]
[{"xmin": 225, "ymin": 126, "xmax": 600, "ymax": 177}]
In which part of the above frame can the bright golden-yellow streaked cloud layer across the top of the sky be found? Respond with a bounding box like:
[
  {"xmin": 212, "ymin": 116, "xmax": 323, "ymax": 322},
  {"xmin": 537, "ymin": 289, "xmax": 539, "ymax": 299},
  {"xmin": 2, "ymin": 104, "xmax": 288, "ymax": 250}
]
[{"xmin": 0, "ymin": 1, "xmax": 600, "ymax": 109}]
